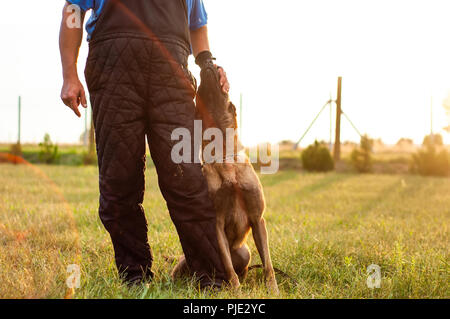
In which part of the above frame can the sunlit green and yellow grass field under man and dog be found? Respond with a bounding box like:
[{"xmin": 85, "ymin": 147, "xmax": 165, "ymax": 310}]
[{"xmin": 0, "ymin": 164, "xmax": 450, "ymax": 298}]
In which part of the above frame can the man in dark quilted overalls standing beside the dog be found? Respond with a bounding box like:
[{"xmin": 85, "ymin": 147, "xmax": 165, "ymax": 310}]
[{"xmin": 60, "ymin": 0, "xmax": 229, "ymax": 287}]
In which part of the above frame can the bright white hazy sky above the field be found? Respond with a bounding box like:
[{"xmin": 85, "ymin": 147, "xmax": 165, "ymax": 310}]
[{"xmin": 0, "ymin": 0, "xmax": 450, "ymax": 146}]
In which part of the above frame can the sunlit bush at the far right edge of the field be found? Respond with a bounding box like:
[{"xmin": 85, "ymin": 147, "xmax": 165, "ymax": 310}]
[{"xmin": 410, "ymin": 144, "xmax": 450, "ymax": 176}]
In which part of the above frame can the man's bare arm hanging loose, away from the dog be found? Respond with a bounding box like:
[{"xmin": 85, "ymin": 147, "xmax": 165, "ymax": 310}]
[{"xmin": 59, "ymin": 2, "xmax": 87, "ymax": 117}]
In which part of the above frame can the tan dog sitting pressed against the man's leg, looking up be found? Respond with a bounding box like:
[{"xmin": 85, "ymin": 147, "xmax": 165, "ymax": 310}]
[{"xmin": 172, "ymin": 63, "xmax": 279, "ymax": 294}]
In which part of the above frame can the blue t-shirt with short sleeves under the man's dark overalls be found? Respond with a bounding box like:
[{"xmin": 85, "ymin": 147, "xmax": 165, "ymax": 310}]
[{"xmin": 67, "ymin": 0, "xmax": 208, "ymax": 41}]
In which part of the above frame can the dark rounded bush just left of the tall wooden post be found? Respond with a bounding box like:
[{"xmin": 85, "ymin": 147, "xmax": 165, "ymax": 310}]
[{"xmin": 302, "ymin": 141, "xmax": 334, "ymax": 172}]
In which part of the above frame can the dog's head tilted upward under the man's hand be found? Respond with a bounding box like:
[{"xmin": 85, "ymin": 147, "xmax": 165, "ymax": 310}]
[{"xmin": 197, "ymin": 63, "xmax": 237, "ymax": 130}]
